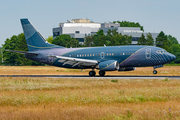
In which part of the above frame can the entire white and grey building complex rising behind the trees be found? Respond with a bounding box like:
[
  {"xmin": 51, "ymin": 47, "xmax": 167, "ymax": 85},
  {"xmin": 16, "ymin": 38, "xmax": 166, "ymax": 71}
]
[{"xmin": 53, "ymin": 19, "xmax": 158, "ymax": 45}]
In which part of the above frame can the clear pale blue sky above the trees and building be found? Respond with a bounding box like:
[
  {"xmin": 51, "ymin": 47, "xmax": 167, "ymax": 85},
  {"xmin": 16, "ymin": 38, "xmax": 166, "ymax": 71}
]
[{"xmin": 0, "ymin": 0, "xmax": 180, "ymax": 46}]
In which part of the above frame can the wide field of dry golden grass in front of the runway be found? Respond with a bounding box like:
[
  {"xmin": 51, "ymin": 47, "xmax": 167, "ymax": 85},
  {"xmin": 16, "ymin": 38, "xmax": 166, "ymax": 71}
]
[{"xmin": 0, "ymin": 78, "xmax": 180, "ymax": 120}]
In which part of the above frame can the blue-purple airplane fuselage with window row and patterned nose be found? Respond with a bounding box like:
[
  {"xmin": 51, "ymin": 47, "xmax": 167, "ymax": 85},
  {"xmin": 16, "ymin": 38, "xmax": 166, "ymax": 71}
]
[{"xmin": 26, "ymin": 46, "xmax": 175, "ymax": 69}]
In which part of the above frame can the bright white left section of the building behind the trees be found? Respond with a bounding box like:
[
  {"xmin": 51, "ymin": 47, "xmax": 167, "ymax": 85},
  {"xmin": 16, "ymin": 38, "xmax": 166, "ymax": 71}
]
[{"xmin": 53, "ymin": 19, "xmax": 101, "ymax": 43}]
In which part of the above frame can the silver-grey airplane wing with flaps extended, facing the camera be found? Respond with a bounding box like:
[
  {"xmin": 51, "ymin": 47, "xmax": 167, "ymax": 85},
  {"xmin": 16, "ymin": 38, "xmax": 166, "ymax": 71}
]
[{"xmin": 48, "ymin": 55, "xmax": 99, "ymax": 67}]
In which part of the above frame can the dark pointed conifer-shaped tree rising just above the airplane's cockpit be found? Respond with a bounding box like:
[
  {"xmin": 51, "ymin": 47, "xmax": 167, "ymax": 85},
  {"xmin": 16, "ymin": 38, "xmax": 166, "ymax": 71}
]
[{"xmin": 156, "ymin": 31, "xmax": 168, "ymax": 51}]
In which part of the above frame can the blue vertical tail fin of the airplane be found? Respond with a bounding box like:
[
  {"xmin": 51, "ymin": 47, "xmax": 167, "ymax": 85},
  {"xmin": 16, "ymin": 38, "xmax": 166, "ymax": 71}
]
[{"xmin": 21, "ymin": 19, "xmax": 63, "ymax": 51}]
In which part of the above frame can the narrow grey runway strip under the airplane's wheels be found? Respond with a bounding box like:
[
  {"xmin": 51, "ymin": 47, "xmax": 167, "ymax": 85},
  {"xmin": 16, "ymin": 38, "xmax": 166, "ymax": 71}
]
[{"xmin": 0, "ymin": 75, "xmax": 180, "ymax": 79}]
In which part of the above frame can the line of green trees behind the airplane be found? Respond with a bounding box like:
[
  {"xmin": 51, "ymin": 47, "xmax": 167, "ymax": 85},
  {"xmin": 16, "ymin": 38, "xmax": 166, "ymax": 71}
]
[{"xmin": 0, "ymin": 23, "xmax": 180, "ymax": 66}]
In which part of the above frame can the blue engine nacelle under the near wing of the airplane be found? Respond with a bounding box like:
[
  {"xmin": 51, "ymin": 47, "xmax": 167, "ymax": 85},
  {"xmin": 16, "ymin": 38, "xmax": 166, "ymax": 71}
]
[{"xmin": 98, "ymin": 60, "xmax": 119, "ymax": 71}]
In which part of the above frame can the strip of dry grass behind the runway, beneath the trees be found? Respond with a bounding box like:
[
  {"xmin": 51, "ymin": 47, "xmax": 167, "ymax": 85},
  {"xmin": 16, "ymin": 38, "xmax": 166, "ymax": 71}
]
[{"xmin": 0, "ymin": 66, "xmax": 180, "ymax": 76}]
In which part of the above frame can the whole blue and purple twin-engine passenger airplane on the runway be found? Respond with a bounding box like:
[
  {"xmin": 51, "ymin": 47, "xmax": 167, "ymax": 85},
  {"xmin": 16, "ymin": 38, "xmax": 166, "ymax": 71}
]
[{"xmin": 6, "ymin": 18, "xmax": 176, "ymax": 77}]
